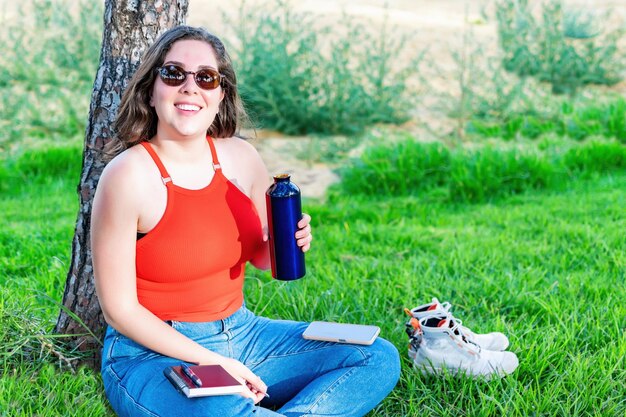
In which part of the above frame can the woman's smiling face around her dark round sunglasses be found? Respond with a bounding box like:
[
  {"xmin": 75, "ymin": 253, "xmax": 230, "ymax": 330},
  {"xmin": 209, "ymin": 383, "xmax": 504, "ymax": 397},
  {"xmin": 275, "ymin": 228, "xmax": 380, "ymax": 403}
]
[{"xmin": 150, "ymin": 40, "xmax": 224, "ymax": 139}]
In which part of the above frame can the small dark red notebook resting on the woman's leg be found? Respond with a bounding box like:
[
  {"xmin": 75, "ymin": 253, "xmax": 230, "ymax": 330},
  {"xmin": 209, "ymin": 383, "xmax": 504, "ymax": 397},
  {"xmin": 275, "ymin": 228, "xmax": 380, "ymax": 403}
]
[{"xmin": 163, "ymin": 365, "xmax": 245, "ymax": 398}]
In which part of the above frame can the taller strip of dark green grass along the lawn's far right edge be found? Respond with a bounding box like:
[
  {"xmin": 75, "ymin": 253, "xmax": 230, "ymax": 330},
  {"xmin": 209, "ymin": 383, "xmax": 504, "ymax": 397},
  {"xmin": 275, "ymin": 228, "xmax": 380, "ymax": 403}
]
[{"xmin": 334, "ymin": 138, "xmax": 626, "ymax": 202}]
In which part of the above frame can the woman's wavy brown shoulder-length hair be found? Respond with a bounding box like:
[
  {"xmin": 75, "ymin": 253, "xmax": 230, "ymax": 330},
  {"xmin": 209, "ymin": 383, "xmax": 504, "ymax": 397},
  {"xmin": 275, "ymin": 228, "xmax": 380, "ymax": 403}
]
[{"xmin": 105, "ymin": 25, "xmax": 249, "ymax": 158}]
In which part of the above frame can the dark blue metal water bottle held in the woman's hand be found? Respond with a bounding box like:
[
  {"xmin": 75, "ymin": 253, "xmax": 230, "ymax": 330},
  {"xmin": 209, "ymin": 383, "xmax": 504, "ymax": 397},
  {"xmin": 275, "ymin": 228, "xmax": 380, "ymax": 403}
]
[{"xmin": 265, "ymin": 174, "xmax": 306, "ymax": 281}]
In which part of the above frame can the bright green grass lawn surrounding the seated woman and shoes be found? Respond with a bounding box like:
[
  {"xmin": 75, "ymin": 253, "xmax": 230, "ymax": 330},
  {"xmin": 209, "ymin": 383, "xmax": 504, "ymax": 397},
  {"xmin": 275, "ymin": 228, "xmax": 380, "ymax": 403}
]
[{"xmin": 0, "ymin": 161, "xmax": 626, "ymax": 417}]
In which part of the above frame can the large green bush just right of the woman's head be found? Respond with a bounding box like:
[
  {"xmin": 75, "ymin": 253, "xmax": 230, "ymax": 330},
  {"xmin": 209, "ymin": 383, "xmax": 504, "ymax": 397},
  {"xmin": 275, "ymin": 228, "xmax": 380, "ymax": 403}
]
[{"xmin": 225, "ymin": 1, "xmax": 416, "ymax": 135}]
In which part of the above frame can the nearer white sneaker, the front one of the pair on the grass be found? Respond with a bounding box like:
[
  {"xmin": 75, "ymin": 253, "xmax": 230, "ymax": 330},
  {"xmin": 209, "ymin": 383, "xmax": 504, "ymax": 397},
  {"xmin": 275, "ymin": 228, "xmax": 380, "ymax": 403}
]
[{"xmin": 409, "ymin": 316, "xmax": 519, "ymax": 379}]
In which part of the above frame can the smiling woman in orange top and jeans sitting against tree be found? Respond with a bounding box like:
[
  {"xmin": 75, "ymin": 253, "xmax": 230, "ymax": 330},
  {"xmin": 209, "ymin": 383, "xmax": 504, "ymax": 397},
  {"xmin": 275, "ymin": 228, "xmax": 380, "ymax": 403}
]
[{"xmin": 91, "ymin": 26, "xmax": 399, "ymax": 417}]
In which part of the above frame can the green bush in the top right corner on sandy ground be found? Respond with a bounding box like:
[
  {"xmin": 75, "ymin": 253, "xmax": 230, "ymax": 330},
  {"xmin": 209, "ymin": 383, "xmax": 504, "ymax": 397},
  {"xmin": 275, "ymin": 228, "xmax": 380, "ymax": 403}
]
[{"xmin": 496, "ymin": 0, "xmax": 626, "ymax": 94}]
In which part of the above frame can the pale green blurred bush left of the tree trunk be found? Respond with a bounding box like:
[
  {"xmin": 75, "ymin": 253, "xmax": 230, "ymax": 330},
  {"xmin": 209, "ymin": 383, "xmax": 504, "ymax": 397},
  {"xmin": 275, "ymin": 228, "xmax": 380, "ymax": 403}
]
[{"xmin": 0, "ymin": 0, "xmax": 102, "ymax": 149}]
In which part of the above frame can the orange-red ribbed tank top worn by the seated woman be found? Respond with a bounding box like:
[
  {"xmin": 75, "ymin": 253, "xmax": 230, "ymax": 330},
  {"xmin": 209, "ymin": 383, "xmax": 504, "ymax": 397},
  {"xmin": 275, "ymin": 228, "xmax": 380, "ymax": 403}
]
[{"xmin": 136, "ymin": 136, "xmax": 263, "ymax": 322}]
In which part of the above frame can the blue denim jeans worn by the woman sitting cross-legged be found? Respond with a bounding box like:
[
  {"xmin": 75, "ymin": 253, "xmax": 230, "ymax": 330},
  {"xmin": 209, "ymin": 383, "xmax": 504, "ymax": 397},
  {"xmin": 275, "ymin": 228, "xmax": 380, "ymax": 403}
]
[{"xmin": 102, "ymin": 306, "xmax": 400, "ymax": 417}]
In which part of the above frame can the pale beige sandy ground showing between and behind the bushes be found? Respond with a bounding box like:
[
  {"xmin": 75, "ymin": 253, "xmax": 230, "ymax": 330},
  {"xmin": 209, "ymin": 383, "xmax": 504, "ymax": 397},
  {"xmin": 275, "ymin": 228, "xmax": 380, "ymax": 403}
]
[{"xmin": 188, "ymin": 0, "xmax": 626, "ymax": 197}]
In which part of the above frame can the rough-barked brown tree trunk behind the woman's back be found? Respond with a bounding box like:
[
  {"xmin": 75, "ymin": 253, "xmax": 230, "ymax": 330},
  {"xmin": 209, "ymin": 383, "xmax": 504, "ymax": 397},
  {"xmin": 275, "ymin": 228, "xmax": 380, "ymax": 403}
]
[{"xmin": 55, "ymin": 0, "xmax": 188, "ymax": 367}]
